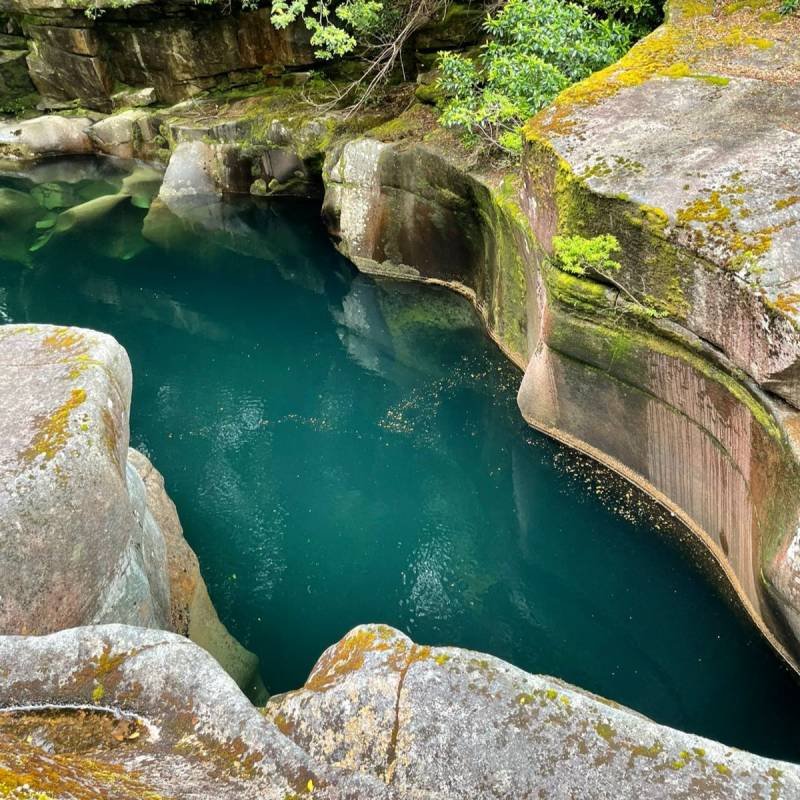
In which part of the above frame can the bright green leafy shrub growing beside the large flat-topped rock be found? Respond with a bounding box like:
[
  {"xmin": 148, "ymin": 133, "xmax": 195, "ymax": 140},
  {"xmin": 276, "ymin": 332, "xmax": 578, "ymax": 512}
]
[{"xmin": 439, "ymin": 0, "xmax": 654, "ymax": 152}]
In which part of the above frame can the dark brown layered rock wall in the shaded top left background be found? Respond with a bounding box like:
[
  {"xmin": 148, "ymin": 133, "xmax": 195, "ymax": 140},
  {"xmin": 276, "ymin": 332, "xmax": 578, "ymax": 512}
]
[{"xmin": 7, "ymin": 0, "xmax": 314, "ymax": 111}]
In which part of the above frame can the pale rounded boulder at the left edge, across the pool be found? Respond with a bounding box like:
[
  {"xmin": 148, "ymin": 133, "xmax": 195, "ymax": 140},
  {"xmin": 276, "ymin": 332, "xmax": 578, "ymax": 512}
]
[{"xmin": 0, "ymin": 116, "xmax": 92, "ymax": 160}]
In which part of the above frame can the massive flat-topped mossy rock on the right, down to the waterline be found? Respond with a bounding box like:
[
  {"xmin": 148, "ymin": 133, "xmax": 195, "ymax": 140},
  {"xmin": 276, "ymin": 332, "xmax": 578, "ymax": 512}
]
[{"xmin": 519, "ymin": 0, "xmax": 800, "ymax": 668}]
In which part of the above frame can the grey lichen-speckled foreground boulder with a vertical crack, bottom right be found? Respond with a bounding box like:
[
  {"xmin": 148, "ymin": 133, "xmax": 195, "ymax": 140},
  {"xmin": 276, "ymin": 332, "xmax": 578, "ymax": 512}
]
[{"xmin": 266, "ymin": 625, "xmax": 800, "ymax": 800}]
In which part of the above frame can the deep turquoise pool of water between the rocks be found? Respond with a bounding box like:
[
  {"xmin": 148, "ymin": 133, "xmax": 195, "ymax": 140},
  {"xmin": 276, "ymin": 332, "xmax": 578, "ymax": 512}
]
[{"xmin": 0, "ymin": 163, "xmax": 800, "ymax": 760}]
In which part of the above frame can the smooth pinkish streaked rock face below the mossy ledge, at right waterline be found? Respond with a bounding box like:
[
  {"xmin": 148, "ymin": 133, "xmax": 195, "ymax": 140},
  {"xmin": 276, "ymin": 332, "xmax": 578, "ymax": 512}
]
[{"xmin": 518, "ymin": 282, "xmax": 799, "ymax": 654}]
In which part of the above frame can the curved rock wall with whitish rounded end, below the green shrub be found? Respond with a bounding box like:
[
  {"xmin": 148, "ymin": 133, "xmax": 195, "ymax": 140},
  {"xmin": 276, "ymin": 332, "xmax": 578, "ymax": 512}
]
[{"xmin": 322, "ymin": 138, "xmax": 532, "ymax": 364}]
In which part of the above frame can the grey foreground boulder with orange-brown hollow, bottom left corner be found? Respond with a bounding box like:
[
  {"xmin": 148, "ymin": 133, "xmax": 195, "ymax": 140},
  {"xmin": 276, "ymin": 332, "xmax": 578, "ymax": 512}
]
[{"xmin": 0, "ymin": 625, "xmax": 387, "ymax": 800}]
